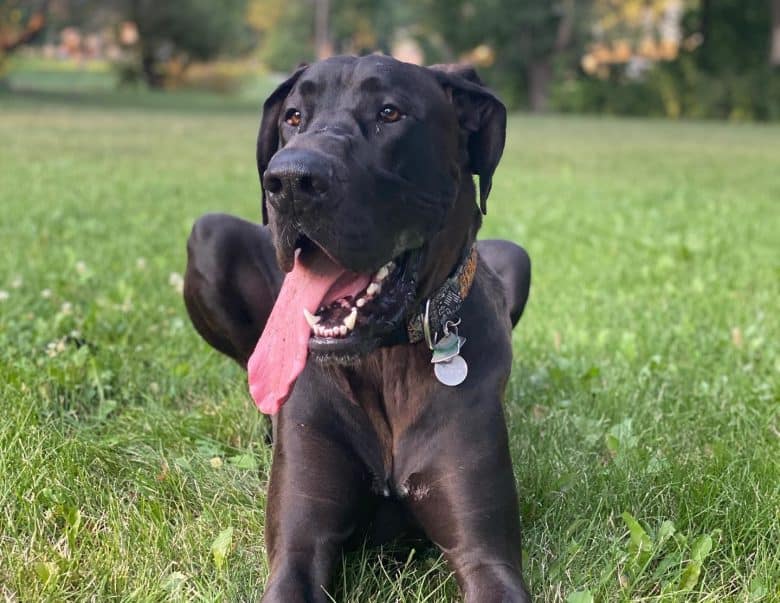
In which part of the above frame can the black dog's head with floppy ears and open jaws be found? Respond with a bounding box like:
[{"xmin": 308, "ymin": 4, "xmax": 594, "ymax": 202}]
[{"xmin": 257, "ymin": 55, "xmax": 506, "ymax": 358}]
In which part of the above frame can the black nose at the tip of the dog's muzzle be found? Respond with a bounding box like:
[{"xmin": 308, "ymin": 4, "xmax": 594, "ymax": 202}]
[{"xmin": 263, "ymin": 149, "xmax": 331, "ymax": 212}]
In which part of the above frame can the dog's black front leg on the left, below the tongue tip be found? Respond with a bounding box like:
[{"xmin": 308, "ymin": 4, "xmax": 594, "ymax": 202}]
[{"xmin": 262, "ymin": 384, "xmax": 367, "ymax": 603}]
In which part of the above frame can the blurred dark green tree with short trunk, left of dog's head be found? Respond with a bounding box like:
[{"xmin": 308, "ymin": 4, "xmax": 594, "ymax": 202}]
[{"xmin": 126, "ymin": 0, "xmax": 247, "ymax": 88}]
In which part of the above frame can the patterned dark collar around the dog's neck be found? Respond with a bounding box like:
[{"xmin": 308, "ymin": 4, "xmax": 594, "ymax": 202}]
[{"xmin": 406, "ymin": 244, "xmax": 477, "ymax": 343}]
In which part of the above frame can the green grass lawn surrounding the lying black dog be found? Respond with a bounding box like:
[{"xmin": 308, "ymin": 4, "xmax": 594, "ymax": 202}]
[{"xmin": 0, "ymin": 86, "xmax": 780, "ymax": 603}]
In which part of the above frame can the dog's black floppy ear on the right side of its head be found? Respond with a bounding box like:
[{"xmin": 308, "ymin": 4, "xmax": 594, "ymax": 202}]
[{"xmin": 429, "ymin": 65, "xmax": 506, "ymax": 214}]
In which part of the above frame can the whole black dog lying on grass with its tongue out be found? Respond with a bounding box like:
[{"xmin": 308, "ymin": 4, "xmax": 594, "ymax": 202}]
[{"xmin": 185, "ymin": 56, "xmax": 530, "ymax": 603}]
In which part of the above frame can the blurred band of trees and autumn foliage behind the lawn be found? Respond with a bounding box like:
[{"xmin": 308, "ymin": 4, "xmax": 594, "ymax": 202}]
[{"xmin": 0, "ymin": 0, "xmax": 780, "ymax": 120}]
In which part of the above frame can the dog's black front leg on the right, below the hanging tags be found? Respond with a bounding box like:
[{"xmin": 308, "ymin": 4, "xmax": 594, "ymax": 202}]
[{"xmin": 402, "ymin": 394, "xmax": 531, "ymax": 603}]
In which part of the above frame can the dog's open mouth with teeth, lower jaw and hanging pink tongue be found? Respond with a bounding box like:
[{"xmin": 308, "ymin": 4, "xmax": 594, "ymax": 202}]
[{"xmin": 247, "ymin": 231, "xmax": 420, "ymax": 414}]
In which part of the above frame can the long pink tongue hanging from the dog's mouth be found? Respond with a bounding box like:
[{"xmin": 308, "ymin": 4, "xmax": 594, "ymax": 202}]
[{"xmin": 247, "ymin": 252, "xmax": 368, "ymax": 415}]
